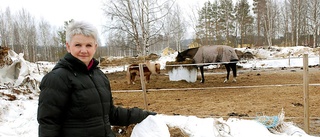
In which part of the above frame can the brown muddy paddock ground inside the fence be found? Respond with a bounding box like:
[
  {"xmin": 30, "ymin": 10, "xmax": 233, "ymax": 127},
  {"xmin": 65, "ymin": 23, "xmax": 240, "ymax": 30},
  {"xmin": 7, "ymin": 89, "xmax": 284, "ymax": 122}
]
[{"xmin": 107, "ymin": 67, "xmax": 320, "ymax": 137}]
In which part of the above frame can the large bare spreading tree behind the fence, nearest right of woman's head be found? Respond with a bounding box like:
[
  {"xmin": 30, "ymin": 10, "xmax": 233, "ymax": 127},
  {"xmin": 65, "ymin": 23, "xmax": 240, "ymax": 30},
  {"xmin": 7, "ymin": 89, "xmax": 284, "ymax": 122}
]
[{"xmin": 103, "ymin": 0, "xmax": 172, "ymax": 55}]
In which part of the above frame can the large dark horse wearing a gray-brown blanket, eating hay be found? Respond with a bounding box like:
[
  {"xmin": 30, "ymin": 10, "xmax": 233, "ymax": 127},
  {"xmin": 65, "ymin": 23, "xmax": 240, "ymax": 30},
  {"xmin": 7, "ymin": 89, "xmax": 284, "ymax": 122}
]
[{"xmin": 176, "ymin": 45, "xmax": 239, "ymax": 83}]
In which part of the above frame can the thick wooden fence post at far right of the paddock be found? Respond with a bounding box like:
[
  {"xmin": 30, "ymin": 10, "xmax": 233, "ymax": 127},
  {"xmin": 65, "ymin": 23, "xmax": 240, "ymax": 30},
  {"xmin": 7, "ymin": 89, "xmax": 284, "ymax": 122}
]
[{"xmin": 303, "ymin": 54, "xmax": 309, "ymax": 134}]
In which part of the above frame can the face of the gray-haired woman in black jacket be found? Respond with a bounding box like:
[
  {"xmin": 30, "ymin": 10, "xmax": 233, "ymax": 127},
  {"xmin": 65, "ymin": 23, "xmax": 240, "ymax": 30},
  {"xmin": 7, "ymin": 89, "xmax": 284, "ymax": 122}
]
[{"xmin": 66, "ymin": 34, "xmax": 97, "ymax": 66}]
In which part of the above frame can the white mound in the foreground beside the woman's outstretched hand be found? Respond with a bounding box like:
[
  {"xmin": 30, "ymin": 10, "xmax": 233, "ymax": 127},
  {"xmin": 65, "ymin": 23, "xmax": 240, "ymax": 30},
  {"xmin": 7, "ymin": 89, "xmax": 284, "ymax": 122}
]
[{"xmin": 131, "ymin": 114, "xmax": 311, "ymax": 137}]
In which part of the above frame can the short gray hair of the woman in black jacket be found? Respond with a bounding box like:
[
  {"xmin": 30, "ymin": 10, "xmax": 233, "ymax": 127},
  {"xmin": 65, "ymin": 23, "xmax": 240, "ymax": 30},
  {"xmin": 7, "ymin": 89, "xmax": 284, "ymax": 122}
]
[{"xmin": 66, "ymin": 20, "xmax": 100, "ymax": 45}]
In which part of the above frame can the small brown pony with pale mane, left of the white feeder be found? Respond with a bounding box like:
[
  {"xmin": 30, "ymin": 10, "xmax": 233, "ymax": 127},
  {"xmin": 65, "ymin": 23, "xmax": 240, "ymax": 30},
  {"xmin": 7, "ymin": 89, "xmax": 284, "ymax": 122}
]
[{"xmin": 127, "ymin": 61, "xmax": 160, "ymax": 84}]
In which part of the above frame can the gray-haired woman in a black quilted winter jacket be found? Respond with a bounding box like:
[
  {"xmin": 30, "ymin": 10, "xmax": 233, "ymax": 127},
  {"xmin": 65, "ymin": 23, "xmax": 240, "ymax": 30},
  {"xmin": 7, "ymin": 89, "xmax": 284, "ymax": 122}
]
[{"xmin": 37, "ymin": 21, "xmax": 156, "ymax": 137}]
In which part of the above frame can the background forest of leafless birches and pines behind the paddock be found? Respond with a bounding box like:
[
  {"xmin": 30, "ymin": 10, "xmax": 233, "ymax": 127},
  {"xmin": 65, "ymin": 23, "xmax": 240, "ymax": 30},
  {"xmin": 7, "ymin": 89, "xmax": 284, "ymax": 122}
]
[{"xmin": 0, "ymin": 0, "xmax": 320, "ymax": 62}]
